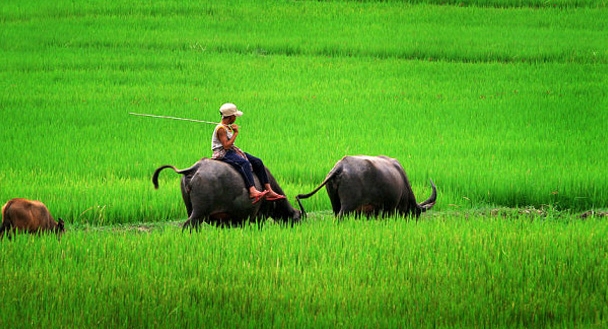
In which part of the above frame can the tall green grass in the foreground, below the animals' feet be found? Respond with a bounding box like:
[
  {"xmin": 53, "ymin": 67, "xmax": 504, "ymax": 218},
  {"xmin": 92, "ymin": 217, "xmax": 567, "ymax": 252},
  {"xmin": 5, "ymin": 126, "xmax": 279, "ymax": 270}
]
[{"xmin": 0, "ymin": 213, "xmax": 608, "ymax": 328}]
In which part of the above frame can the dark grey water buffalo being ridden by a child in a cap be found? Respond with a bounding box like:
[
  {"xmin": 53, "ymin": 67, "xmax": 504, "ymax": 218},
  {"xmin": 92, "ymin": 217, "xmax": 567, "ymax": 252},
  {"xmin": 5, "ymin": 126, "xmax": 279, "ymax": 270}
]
[{"xmin": 152, "ymin": 158, "xmax": 301, "ymax": 228}]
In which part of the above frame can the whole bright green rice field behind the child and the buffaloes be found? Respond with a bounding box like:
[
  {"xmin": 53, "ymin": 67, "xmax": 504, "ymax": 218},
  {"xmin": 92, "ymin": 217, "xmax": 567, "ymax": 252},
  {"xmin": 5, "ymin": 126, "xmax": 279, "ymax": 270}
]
[{"xmin": 0, "ymin": 1, "xmax": 608, "ymax": 224}]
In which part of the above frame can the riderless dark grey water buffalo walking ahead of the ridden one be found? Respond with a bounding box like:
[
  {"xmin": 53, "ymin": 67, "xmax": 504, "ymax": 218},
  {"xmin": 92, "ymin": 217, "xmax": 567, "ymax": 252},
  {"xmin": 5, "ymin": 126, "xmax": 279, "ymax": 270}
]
[{"xmin": 296, "ymin": 156, "xmax": 437, "ymax": 217}]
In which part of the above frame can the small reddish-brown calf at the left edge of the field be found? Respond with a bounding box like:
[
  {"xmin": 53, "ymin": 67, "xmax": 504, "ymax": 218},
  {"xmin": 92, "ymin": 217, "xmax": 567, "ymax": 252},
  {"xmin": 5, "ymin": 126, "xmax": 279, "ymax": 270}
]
[{"xmin": 0, "ymin": 198, "xmax": 65, "ymax": 238}]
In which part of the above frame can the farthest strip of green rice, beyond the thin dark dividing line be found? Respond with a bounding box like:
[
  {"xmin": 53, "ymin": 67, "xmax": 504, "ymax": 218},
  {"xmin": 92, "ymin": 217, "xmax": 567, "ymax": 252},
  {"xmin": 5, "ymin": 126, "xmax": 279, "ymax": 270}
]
[{"xmin": 4, "ymin": 1, "xmax": 607, "ymax": 62}]
